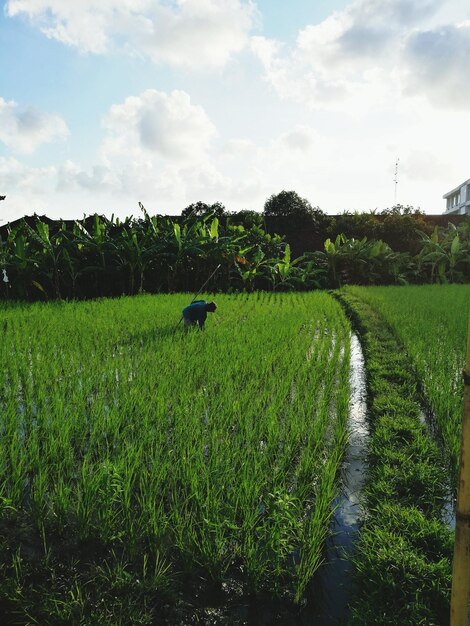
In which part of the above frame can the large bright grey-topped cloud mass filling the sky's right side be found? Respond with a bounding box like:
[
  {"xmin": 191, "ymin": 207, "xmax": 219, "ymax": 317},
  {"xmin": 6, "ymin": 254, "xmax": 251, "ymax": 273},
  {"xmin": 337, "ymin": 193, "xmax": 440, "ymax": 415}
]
[{"xmin": 246, "ymin": 0, "xmax": 470, "ymax": 212}]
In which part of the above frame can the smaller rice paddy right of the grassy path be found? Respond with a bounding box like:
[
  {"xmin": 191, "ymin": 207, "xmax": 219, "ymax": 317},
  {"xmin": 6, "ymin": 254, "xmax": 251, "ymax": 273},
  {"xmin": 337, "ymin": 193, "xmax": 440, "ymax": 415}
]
[{"xmin": 347, "ymin": 285, "xmax": 470, "ymax": 481}]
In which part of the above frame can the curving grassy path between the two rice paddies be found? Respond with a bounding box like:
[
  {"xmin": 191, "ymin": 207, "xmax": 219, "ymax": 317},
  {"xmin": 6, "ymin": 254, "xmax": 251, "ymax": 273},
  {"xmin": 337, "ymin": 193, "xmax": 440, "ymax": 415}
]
[{"xmin": 336, "ymin": 290, "xmax": 453, "ymax": 626}]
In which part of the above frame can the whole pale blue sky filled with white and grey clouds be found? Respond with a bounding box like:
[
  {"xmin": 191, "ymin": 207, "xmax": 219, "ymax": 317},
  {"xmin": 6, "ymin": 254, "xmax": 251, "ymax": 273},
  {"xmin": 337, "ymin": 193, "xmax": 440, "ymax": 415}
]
[{"xmin": 0, "ymin": 0, "xmax": 470, "ymax": 223}]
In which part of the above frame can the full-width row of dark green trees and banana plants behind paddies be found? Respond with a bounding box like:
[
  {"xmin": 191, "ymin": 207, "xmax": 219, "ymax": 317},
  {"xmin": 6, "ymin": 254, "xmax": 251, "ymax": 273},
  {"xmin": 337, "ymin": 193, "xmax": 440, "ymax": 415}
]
[{"xmin": 0, "ymin": 191, "xmax": 470, "ymax": 300}]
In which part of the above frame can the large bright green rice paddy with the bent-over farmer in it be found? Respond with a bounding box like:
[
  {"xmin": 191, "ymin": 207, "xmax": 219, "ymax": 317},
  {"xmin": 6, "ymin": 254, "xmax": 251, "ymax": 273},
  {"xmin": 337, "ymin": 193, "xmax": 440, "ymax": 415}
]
[{"xmin": 0, "ymin": 292, "xmax": 350, "ymax": 624}]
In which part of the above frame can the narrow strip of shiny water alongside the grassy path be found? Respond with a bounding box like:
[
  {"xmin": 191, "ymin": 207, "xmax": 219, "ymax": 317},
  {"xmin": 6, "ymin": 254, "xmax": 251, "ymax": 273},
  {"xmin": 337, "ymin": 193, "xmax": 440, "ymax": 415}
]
[{"xmin": 314, "ymin": 334, "xmax": 369, "ymax": 626}]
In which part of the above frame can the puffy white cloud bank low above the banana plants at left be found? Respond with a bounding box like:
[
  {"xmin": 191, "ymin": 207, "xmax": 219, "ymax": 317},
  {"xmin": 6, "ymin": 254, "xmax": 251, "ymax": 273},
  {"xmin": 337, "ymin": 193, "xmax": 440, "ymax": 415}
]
[{"xmin": 0, "ymin": 113, "xmax": 324, "ymax": 217}]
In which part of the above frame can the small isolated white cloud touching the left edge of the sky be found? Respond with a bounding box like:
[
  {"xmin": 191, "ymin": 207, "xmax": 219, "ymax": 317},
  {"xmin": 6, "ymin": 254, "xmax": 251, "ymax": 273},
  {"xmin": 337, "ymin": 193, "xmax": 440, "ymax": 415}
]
[{"xmin": 0, "ymin": 97, "xmax": 68, "ymax": 154}]
